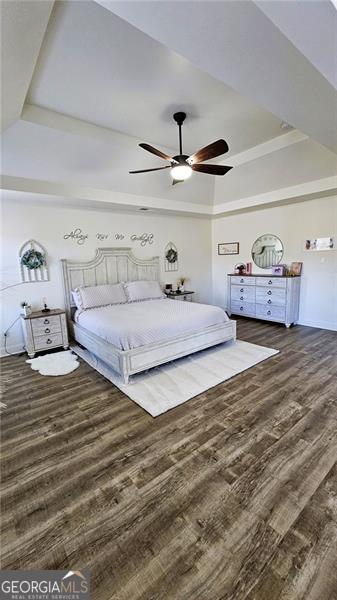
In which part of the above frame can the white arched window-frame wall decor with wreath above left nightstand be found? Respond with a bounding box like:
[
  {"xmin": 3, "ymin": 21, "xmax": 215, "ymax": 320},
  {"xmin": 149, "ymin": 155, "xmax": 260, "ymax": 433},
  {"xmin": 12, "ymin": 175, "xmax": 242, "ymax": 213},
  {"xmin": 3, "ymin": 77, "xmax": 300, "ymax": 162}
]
[{"xmin": 19, "ymin": 240, "xmax": 49, "ymax": 283}]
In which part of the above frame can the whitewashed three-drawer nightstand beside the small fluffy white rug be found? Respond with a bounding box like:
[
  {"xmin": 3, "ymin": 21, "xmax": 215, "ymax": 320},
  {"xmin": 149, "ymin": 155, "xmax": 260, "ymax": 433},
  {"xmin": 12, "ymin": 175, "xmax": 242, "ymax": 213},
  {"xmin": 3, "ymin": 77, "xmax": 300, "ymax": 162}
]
[{"xmin": 21, "ymin": 308, "xmax": 69, "ymax": 358}]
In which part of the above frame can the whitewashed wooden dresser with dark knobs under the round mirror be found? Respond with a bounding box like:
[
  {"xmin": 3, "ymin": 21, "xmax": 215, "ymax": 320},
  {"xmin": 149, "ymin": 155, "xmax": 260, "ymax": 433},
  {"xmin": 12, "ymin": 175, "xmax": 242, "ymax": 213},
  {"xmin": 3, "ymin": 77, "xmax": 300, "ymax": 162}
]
[{"xmin": 228, "ymin": 274, "xmax": 301, "ymax": 327}]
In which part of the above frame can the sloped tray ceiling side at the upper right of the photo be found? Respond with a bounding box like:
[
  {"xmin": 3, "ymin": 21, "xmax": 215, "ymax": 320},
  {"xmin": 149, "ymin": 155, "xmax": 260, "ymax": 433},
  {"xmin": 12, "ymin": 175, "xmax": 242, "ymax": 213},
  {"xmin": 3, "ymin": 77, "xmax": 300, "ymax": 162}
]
[{"xmin": 107, "ymin": 0, "xmax": 337, "ymax": 152}]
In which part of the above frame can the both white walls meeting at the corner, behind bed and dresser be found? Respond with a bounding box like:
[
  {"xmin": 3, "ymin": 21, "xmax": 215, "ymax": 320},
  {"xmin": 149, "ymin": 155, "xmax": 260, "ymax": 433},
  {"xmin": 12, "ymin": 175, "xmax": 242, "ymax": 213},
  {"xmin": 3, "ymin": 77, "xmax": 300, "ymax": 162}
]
[{"xmin": 0, "ymin": 196, "xmax": 337, "ymax": 353}]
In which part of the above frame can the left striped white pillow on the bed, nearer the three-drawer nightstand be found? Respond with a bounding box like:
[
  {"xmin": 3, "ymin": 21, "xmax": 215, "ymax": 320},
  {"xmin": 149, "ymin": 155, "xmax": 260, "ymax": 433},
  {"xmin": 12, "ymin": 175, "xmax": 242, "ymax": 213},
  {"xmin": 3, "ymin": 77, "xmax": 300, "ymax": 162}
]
[{"xmin": 72, "ymin": 283, "xmax": 127, "ymax": 310}]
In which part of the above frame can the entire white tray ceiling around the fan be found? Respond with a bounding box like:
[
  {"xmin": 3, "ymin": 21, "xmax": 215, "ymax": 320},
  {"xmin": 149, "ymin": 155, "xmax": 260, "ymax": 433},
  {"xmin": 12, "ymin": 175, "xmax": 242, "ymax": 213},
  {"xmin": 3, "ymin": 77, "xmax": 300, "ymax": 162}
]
[{"xmin": 1, "ymin": 0, "xmax": 337, "ymax": 214}]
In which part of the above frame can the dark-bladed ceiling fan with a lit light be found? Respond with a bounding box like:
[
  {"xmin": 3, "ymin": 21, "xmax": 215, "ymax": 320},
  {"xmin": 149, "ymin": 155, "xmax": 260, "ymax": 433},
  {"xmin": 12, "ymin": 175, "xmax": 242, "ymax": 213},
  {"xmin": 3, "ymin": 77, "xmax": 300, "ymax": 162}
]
[{"xmin": 129, "ymin": 112, "xmax": 233, "ymax": 185}]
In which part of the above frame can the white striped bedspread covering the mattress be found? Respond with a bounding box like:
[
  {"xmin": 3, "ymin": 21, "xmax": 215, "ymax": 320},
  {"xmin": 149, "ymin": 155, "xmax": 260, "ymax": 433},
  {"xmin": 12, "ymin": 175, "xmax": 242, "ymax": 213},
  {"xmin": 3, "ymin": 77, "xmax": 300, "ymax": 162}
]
[{"xmin": 75, "ymin": 298, "xmax": 229, "ymax": 350}]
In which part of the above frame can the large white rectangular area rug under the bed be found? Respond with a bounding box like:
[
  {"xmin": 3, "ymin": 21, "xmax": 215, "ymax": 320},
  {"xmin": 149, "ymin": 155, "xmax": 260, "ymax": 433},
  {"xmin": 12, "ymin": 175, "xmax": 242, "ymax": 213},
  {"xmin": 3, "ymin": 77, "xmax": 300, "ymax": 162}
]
[{"xmin": 72, "ymin": 340, "xmax": 278, "ymax": 417}]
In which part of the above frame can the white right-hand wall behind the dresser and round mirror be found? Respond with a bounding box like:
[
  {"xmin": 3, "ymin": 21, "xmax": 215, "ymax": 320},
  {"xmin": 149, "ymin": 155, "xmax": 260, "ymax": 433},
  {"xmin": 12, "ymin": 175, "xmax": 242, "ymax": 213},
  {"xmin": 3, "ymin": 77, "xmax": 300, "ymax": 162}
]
[{"xmin": 212, "ymin": 197, "xmax": 337, "ymax": 330}]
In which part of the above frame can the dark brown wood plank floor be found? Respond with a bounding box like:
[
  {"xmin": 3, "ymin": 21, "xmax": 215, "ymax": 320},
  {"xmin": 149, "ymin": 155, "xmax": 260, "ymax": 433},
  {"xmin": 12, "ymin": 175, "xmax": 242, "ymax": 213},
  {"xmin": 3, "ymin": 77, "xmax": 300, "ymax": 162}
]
[{"xmin": 1, "ymin": 319, "xmax": 337, "ymax": 600}]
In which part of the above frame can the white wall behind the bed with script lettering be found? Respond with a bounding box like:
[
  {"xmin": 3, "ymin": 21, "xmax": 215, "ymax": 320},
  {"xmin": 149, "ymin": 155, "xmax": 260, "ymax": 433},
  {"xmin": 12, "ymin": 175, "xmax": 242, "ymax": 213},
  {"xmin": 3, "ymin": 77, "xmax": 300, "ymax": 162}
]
[{"xmin": 0, "ymin": 197, "xmax": 212, "ymax": 353}]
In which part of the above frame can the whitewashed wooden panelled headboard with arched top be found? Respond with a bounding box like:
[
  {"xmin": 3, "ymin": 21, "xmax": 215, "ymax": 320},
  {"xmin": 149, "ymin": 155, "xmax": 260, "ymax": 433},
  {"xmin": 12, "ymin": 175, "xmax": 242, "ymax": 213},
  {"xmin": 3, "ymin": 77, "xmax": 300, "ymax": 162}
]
[{"xmin": 61, "ymin": 248, "xmax": 159, "ymax": 319}]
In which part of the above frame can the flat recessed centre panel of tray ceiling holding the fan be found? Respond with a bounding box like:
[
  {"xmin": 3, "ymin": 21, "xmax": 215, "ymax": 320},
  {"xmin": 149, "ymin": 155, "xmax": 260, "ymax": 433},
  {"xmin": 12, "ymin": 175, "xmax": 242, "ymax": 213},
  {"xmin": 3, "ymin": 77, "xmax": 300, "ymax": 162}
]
[{"xmin": 28, "ymin": 2, "xmax": 281, "ymax": 156}]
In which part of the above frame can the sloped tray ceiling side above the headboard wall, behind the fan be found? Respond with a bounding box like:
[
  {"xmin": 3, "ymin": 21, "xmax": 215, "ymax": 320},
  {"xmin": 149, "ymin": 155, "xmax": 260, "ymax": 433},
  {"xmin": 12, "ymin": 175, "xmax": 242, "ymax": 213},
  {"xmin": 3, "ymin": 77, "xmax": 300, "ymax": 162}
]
[{"xmin": 2, "ymin": 120, "xmax": 214, "ymax": 205}]
